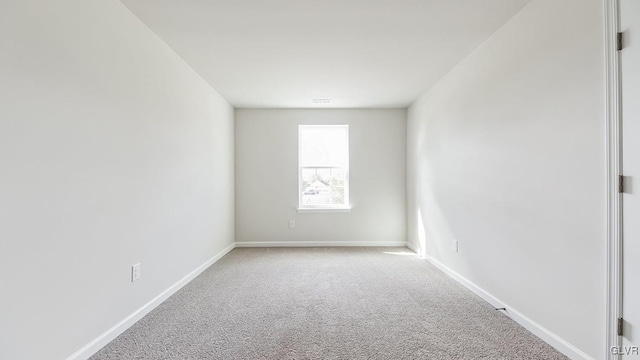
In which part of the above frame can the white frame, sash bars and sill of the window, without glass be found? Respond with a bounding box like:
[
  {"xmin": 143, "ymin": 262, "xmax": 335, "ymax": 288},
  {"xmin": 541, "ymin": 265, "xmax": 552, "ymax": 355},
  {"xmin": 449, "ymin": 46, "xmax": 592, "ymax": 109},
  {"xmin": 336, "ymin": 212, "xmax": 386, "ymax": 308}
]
[{"xmin": 298, "ymin": 125, "xmax": 351, "ymax": 213}]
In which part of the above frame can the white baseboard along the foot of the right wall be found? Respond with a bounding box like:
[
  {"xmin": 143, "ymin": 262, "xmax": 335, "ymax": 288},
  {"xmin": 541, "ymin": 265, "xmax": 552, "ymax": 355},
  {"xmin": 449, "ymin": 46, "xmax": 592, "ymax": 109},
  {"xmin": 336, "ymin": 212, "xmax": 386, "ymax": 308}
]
[{"xmin": 424, "ymin": 255, "xmax": 595, "ymax": 360}]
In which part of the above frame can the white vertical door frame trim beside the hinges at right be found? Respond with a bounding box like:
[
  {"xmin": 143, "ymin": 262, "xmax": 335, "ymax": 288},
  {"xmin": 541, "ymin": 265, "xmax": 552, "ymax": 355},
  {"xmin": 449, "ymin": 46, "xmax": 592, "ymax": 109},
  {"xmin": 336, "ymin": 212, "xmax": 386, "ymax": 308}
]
[{"xmin": 604, "ymin": 0, "xmax": 622, "ymax": 360}]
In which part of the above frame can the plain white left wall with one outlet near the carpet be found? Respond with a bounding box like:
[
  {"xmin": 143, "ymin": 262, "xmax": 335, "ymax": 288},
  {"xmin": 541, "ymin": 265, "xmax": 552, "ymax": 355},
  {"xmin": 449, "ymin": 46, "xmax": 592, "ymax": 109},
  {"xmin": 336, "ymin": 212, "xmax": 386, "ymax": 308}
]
[{"xmin": 0, "ymin": 0, "xmax": 234, "ymax": 360}]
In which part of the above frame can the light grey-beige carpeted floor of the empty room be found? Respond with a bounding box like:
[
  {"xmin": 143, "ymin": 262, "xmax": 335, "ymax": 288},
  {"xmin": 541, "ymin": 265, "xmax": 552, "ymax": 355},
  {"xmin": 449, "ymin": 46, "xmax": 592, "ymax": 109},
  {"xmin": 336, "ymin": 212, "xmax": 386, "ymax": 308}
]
[{"xmin": 91, "ymin": 248, "xmax": 566, "ymax": 360}]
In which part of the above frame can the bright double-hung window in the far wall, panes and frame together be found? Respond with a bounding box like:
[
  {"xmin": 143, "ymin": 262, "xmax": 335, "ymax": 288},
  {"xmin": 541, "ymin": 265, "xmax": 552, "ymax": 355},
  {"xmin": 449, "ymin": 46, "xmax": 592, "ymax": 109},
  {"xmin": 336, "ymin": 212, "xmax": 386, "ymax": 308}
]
[{"xmin": 298, "ymin": 125, "xmax": 349, "ymax": 209}]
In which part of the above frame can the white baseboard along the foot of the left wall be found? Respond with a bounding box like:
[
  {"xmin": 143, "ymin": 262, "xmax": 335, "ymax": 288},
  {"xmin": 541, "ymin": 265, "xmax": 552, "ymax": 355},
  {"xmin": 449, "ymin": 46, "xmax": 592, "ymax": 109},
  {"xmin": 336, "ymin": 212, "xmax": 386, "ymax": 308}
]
[{"xmin": 67, "ymin": 243, "xmax": 235, "ymax": 360}]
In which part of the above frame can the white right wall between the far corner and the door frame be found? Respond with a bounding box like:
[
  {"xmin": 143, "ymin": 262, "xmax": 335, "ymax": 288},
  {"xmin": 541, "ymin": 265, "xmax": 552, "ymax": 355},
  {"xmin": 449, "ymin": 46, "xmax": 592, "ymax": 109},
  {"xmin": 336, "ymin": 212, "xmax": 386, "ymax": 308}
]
[{"xmin": 407, "ymin": 0, "xmax": 606, "ymax": 359}]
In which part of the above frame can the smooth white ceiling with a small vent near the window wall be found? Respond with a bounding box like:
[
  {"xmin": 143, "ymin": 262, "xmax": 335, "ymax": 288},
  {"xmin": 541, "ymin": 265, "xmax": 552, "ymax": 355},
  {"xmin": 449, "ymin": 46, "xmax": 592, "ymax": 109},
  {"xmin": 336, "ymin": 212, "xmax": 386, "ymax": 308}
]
[{"xmin": 121, "ymin": 0, "xmax": 530, "ymax": 108}]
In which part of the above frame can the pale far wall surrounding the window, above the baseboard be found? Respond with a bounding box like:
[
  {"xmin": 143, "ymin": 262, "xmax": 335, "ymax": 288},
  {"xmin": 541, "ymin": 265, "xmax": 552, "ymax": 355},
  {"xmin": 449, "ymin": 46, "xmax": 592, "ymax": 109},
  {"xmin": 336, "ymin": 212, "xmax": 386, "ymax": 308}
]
[{"xmin": 235, "ymin": 109, "xmax": 406, "ymax": 245}]
